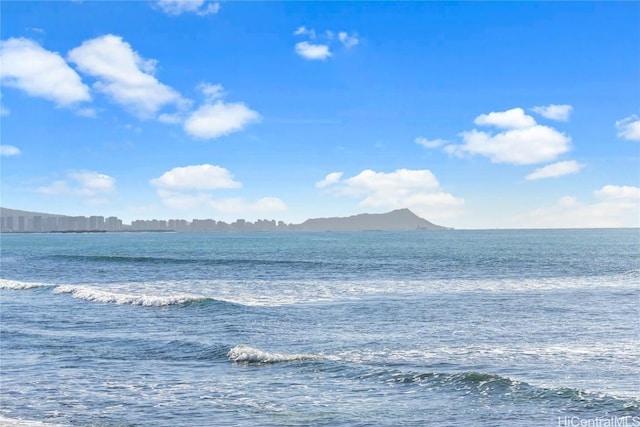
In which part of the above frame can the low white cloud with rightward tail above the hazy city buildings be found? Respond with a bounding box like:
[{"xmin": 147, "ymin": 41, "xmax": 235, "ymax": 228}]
[{"xmin": 150, "ymin": 164, "xmax": 287, "ymax": 214}]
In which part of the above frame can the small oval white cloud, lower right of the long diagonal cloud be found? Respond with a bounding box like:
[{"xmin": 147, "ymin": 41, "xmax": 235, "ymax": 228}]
[{"xmin": 184, "ymin": 101, "xmax": 260, "ymax": 139}]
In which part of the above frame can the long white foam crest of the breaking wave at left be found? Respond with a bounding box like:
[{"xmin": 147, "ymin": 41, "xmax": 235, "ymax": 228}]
[{"xmin": 53, "ymin": 285, "xmax": 206, "ymax": 307}]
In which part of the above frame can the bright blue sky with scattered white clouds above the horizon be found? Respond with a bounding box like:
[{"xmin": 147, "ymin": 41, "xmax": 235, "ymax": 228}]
[{"xmin": 0, "ymin": 0, "xmax": 640, "ymax": 229}]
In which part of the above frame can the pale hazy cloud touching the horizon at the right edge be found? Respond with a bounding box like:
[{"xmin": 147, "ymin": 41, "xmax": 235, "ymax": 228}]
[{"xmin": 513, "ymin": 185, "xmax": 640, "ymax": 228}]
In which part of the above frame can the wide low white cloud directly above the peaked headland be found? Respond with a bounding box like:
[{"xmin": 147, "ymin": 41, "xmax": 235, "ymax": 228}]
[{"xmin": 316, "ymin": 169, "xmax": 464, "ymax": 218}]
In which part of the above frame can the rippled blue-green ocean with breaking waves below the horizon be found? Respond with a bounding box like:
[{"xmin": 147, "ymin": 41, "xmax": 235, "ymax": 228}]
[{"xmin": 0, "ymin": 229, "xmax": 640, "ymax": 427}]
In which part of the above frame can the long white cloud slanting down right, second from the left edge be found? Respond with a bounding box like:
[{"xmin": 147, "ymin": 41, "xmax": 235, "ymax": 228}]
[{"xmin": 68, "ymin": 34, "xmax": 184, "ymax": 118}]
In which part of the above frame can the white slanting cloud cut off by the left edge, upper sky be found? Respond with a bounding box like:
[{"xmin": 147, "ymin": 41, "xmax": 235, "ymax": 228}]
[{"xmin": 0, "ymin": 38, "xmax": 91, "ymax": 107}]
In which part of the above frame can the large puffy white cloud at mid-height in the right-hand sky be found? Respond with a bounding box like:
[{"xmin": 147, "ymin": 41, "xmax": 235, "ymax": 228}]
[{"xmin": 445, "ymin": 108, "xmax": 571, "ymax": 165}]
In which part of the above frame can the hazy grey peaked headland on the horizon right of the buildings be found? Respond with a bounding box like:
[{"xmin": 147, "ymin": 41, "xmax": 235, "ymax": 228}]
[{"xmin": 291, "ymin": 209, "xmax": 447, "ymax": 231}]
